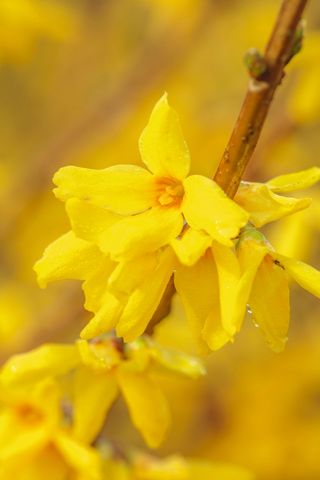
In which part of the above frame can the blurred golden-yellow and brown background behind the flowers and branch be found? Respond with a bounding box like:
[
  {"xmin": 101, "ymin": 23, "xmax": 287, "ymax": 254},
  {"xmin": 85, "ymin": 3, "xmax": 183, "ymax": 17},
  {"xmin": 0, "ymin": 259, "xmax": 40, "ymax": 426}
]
[{"xmin": 0, "ymin": 0, "xmax": 320, "ymax": 480}]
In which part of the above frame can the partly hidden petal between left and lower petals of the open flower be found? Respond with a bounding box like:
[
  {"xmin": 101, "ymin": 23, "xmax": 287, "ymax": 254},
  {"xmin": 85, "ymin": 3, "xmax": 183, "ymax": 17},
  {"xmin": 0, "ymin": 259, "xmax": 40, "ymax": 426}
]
[{"xmin": 66, "ymin": 198, "xmax": 122, "ymax": 244}]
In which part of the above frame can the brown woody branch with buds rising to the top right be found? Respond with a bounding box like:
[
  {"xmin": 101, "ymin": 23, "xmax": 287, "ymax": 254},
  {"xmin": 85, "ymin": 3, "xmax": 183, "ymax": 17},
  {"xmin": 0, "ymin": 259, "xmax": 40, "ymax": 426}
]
[{"xmin": 214, "ymin": 0, "xmax": 308, "ymax": 198}]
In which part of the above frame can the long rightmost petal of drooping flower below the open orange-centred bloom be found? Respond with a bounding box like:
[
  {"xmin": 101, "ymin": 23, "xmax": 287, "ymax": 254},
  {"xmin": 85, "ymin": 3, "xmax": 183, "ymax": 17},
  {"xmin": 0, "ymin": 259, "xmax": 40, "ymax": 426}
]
[{"xmin": 116, "ymin": 248, "xmax": 175, "ymax": 342}]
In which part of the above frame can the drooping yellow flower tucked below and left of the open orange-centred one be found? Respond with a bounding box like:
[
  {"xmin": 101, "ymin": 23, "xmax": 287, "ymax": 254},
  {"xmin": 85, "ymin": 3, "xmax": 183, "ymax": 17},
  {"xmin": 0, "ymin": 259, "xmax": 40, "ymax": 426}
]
[{"xmin": 35, "ymin": 231, "xmax": 176, "ymax": 341}]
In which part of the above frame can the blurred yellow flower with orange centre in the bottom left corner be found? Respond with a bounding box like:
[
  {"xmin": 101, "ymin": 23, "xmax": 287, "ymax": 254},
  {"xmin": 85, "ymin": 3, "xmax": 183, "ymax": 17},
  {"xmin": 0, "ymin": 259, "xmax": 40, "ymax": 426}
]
[{"xmin": 0, "ymin": 380, "xmax": 102, "ymax": 480}]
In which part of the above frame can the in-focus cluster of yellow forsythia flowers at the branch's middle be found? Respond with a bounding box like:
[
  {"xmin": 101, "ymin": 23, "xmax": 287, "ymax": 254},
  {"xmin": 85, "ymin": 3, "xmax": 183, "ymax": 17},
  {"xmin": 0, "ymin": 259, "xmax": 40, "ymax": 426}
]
[{"xmin": 35, "ymin": 95, "xmax": 320, "ymax": 352}]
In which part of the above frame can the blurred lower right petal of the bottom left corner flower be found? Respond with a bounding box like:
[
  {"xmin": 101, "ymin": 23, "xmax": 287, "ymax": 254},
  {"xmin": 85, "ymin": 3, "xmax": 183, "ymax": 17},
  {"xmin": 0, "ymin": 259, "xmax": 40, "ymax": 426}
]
[{"xmin": 55, "ymin": 431, "xmax": 102, "ymax": 480}]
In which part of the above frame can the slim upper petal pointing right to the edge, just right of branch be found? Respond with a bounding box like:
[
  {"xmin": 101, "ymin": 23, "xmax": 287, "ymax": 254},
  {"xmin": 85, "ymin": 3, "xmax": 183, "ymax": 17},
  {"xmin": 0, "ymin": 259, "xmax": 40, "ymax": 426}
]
[{"xmin": 266, "ymin": 167, "xmax": 320, "ymax": 193}]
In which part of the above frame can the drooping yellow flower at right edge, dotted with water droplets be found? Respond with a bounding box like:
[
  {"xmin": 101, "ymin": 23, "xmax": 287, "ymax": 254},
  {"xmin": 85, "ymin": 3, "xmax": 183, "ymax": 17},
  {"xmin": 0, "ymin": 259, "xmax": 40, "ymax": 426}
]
[{"xmin": 231, "ymin": 229, "xmax": 320, "ymax": 351}]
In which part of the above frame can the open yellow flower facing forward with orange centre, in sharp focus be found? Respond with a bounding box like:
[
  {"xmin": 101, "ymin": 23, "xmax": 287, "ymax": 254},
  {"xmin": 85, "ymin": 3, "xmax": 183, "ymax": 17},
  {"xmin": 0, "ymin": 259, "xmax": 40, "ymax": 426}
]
[{"xmin": 54, "ymin": 95, "xmax": 248, "ymax": 260}]
